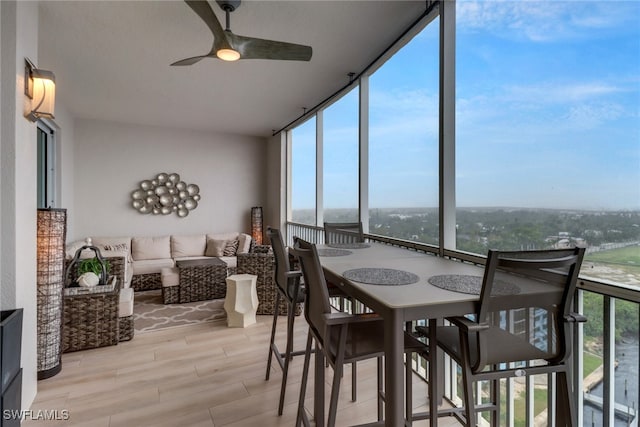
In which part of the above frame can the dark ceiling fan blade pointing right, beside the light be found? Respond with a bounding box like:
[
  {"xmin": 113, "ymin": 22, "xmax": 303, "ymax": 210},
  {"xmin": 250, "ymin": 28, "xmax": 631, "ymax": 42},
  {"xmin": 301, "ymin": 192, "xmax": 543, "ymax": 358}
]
[{"xmin": 225, "ymin": 31, "xmax": 313, "ymax": 61}]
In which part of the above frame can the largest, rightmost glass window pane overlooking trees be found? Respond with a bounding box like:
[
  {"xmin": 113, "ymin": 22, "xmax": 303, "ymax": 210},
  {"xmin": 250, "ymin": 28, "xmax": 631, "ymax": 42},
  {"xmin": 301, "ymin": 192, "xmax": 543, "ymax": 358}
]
[{"xmin": 456, "ymin": 1, "xmax": 640, "ymax": 286}]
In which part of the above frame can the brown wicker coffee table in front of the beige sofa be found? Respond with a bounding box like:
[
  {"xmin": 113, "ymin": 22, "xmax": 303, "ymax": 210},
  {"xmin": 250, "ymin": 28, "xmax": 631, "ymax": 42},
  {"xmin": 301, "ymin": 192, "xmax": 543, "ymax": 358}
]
[{"xmin": 176, "ymin": 258, "xmax": 227, "ymax": 303}]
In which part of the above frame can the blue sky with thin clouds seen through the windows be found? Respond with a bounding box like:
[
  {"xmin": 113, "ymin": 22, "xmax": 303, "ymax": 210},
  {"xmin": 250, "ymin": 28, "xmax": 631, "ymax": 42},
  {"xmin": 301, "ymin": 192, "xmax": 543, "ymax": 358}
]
[{"xmin": 293, "ymin": 1, "xmax": 640, "ymax": 210}]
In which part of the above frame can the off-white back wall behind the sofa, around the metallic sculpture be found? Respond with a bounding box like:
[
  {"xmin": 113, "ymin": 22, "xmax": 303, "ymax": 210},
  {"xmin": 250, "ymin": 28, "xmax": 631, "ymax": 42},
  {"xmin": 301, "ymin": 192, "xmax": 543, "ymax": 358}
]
[{"xmin": 70, "ymin": 119, "xmax": 267, "ymax": 241}]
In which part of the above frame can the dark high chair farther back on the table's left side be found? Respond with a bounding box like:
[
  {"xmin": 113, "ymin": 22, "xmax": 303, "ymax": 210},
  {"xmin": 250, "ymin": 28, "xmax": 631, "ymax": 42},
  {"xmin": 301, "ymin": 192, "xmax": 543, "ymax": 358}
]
[{"xmin": 265, "ymin": 227, "xmax": 305, "ymax": 415}]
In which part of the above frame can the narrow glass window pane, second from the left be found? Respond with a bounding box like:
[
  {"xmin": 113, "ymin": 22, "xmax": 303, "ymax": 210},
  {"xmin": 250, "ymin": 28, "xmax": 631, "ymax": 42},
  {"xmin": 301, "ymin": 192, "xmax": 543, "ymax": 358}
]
[{"xmin": 323, "ymin": 88, "xmax": 359, "ymax": 222}]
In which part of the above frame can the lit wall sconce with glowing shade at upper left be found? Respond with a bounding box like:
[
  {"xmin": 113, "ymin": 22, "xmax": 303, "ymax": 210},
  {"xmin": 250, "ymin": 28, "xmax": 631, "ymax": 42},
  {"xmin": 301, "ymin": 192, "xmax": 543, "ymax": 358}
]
[{"xmin": 24, "ymin": 58, "xmax": 56, "ymax": 122}]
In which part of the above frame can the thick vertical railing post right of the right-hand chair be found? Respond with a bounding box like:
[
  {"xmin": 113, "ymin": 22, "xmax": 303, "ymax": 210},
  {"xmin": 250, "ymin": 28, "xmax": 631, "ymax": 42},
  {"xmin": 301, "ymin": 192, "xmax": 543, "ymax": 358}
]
[{"xmin": 602, "ymin": 296, "xmax": 616, "ymax": 426}]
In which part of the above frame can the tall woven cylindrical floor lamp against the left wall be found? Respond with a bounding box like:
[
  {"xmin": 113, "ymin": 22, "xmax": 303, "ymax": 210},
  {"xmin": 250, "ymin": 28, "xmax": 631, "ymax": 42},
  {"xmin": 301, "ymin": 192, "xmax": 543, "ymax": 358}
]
[{"xmin": 37, "ymin": 208, "xmax": 67, "ymax": 380}]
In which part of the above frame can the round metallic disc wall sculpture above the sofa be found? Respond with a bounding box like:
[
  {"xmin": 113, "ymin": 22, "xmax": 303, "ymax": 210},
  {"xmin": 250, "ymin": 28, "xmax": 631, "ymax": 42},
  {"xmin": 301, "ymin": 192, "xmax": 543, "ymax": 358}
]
[{"xmin": 131, "ymin": 172, "xmax": 200, "ymax": 218}]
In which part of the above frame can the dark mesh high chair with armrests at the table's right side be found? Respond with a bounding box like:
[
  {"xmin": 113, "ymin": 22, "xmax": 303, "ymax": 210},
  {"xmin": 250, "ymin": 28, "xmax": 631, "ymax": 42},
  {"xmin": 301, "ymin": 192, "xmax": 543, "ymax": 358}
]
[{"xmin": 417, "ymin": 248, "xmax": 586, "ymax": 426}]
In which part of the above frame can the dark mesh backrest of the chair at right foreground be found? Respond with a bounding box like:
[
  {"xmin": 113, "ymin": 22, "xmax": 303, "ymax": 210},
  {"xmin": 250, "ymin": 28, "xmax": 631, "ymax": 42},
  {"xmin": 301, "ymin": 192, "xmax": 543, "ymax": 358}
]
[{"xmin": 477, "ymin": 248, "xmax": 584, "ymax": 368}]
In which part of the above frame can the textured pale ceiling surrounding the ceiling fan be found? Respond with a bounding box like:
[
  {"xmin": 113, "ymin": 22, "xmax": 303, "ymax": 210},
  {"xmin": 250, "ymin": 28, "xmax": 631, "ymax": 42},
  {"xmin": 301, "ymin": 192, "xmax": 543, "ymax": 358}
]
[{"xmin": 37, "ymin": 0, "xmax": 425, "ymax": 136}]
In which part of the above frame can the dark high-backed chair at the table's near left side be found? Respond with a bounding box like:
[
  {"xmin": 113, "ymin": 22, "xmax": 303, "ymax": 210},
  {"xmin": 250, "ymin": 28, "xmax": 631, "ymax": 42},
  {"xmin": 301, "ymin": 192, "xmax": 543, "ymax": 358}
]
[{"xmin": 292, "ymin": 237, "xmax": 424, "ymax": 427}]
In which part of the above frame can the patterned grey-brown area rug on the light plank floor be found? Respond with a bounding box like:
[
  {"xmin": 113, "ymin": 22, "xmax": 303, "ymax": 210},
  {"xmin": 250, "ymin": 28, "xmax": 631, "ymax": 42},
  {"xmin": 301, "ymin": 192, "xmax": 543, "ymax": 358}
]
[{"xmin": 133, "ymin": 290, "xmax": 227, "ymax": 333}]
